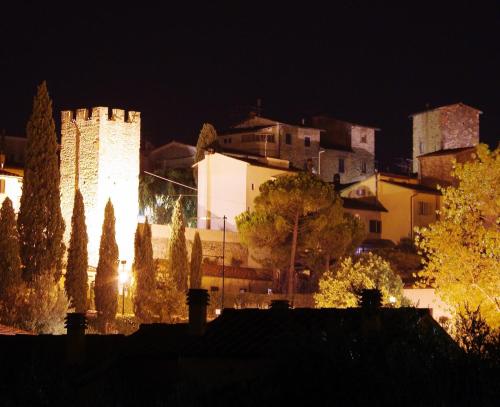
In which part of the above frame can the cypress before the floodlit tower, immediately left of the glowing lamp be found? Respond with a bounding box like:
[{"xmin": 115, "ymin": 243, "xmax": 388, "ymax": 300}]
[{"xmin": 94, "ymin": 199, "xmax": 118, "ymax": 333}]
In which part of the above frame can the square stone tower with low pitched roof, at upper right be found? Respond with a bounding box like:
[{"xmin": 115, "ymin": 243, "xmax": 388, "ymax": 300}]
[{"xmin": 411, "ymin": 103, "xmax": 482, "ymax": 172}]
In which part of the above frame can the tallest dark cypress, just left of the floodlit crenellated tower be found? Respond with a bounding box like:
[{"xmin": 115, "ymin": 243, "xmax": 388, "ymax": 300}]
[{"xmin": 18, "ymin": 82, "xmax": 64, "ymax": 281}]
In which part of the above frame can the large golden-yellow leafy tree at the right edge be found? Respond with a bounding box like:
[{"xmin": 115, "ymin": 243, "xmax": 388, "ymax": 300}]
[{"xmin": 416, "ymin": 144, "xmax": 500, "ymax": 328}]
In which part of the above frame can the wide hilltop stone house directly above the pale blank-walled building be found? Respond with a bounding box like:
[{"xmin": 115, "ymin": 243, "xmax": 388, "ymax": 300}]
[{"xmin": 218, "ymin": 116, "xmax": 320, "ymax": 170}]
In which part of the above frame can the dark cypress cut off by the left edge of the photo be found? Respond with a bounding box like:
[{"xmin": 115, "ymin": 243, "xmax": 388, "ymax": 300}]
[{"xmin": 0, "ymin": 198, "xmax": 24, "ymax": 325}]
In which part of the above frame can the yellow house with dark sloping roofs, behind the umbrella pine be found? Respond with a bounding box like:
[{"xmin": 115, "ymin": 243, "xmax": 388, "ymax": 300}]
[{"xmin": 341, "ymin": 173, "xmax": 441, "ymax": 244}]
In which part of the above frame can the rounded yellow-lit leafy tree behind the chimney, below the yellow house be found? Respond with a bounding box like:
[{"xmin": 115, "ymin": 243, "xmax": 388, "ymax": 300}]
[{"xmin": 314, "ymin": 253, "xmax": 404, "ymax": 308}]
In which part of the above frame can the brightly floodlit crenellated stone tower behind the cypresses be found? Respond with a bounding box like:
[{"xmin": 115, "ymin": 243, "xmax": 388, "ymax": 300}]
[{"xmin": 61, "ymin": 107, "xmax": 141, "ymax": 270}]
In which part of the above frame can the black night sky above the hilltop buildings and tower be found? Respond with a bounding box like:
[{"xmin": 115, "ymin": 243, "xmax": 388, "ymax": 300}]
[{"xmin": 0, "ymin": 0, "xmax": 500, "ymax": 169}]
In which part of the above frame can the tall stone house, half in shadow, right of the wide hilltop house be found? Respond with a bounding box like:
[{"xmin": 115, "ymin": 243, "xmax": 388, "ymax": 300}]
[{"xmin": 312, "ymin": 116, "xmax": 379, "ymax": 184}]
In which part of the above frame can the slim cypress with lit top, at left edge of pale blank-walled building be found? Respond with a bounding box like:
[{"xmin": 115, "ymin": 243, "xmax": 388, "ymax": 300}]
[{"xmin": 167, "ymin": 197, "xmax": 188, "ymax": 292}]
